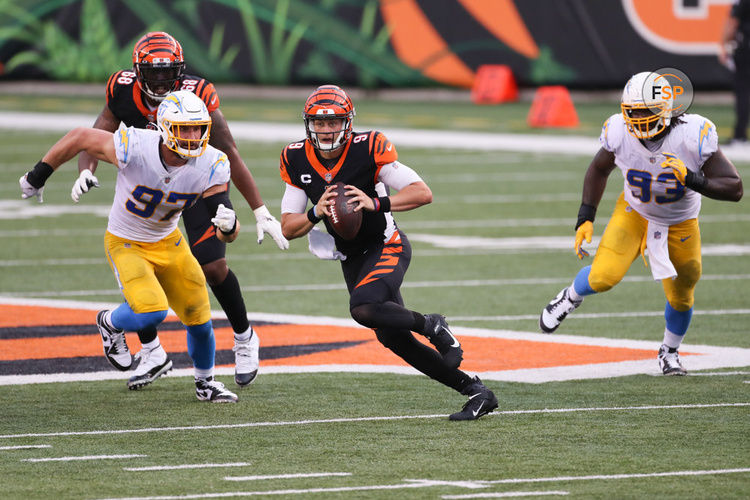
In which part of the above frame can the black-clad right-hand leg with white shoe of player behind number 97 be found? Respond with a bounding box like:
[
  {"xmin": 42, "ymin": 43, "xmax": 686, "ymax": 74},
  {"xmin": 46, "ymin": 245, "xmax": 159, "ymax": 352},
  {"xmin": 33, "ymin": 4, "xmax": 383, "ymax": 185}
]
[{"xmin": 182, "ymin": 198, "xmax": 260, "ymax": 387}]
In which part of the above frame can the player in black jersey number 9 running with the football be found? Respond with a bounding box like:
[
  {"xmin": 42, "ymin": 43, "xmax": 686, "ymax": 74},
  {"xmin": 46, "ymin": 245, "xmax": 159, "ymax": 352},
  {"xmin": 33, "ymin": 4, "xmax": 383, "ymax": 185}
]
[{"xmin": 280, "ymin": 85, "xmax": 497, "ymax": 420}]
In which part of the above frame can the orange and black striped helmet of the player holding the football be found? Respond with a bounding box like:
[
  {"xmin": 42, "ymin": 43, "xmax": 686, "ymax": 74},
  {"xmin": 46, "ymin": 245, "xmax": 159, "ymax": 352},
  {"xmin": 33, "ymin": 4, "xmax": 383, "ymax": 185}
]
[{"xmin": 302, "ymin": 85, "xmax": 356, "ymax": 151}]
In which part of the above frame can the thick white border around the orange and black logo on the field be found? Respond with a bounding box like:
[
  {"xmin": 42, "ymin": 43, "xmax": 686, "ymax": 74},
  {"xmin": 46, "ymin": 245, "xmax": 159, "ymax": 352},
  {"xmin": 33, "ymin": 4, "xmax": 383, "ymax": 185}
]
[{"xmin": 0, "ymin": 297, "xmax": 750, "ymax": 385}]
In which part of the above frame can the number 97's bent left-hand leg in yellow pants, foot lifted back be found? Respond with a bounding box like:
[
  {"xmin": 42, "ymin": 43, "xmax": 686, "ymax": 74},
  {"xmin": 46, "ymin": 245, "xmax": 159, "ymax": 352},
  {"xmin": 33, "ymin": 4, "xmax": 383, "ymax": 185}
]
[{"xmin": 96, "ymin": 233, "xmax": 167, "ymax": 370}]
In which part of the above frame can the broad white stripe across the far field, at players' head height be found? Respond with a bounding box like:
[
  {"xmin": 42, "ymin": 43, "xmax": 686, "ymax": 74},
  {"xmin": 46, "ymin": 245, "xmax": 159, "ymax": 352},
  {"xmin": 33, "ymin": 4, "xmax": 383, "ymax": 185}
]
[{"xmin": 0, "ymin": 111, "xmax": 750, "ymax": 161}]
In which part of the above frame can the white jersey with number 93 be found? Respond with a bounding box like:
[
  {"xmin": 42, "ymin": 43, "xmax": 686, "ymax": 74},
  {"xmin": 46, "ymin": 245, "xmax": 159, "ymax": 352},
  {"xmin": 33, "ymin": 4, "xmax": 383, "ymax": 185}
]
[{"xmin": 599, "ymin": 114, "xmax": 719, "ymax": 225}]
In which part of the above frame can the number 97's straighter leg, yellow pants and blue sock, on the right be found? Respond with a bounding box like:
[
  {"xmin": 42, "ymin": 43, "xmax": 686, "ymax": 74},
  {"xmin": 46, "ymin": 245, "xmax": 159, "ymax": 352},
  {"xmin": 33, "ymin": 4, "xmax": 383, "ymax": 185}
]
[{"xmin": 157, "ymin": 231, "xmax": 237, "ymax": 403}]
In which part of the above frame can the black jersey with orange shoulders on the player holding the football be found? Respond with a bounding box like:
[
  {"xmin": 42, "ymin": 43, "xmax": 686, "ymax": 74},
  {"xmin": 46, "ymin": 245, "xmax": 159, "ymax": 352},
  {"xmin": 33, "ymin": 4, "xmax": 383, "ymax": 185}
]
[{"xmin": 279, "ymin": 131, "xmax": 398, "ymax": 255}]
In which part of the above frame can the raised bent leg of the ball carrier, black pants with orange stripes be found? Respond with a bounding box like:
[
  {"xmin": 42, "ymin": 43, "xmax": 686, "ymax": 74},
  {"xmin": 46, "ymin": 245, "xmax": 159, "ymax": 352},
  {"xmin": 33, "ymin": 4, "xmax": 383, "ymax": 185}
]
[{"xmin": 342, "ymin": 232, "xmax": 463, "ymax": 368}]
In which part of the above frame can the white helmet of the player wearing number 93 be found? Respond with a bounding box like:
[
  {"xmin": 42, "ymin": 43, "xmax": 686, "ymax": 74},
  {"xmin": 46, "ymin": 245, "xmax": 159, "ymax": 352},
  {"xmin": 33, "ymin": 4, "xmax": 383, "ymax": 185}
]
[{"xmin": 620, "ymin": 71, "xmax": 674, "ymax": 139}]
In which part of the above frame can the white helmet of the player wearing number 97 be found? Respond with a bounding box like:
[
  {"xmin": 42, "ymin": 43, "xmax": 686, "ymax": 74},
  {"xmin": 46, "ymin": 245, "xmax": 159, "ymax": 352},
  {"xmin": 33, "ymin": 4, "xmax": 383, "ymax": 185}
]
[{"xmin": 156, "ymin": 90, "xmax": 211, "ymax": 158}]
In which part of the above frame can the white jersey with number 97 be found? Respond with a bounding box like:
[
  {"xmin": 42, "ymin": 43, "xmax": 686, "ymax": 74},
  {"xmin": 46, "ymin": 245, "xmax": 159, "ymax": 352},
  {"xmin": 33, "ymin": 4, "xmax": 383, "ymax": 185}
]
[{"xmin": 107, "ymin": 125, "xmax": 229, "ymax": 243}]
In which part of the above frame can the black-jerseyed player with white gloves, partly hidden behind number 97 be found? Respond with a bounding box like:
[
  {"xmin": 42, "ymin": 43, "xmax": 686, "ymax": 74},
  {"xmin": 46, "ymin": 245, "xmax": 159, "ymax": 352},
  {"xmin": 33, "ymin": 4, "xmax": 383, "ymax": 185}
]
[{"xmin": 71, "ymin": 31, "xmax": 289, "ymax": 388}]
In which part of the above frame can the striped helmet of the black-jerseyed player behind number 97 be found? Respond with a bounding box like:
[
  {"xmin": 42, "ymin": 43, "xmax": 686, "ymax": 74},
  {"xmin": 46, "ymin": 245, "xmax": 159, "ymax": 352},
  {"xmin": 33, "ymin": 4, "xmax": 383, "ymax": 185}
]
[{"xmin": 133, "ymin": 31, "xmax": 185, "ymax": 101}]
